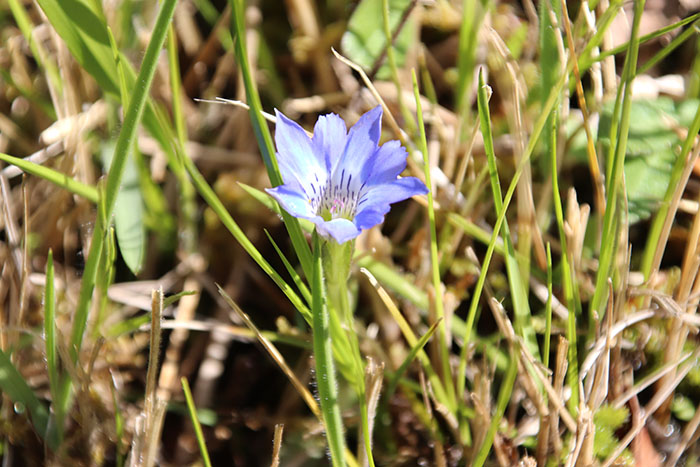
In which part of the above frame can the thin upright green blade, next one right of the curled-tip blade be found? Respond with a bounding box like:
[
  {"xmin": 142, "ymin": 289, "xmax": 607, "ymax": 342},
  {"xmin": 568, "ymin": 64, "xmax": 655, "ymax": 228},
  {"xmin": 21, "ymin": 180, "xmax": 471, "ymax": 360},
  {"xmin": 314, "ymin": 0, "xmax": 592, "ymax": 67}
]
[{"xmin": 547, "ymin": 114, "xmax": 581, "ymax": 413}]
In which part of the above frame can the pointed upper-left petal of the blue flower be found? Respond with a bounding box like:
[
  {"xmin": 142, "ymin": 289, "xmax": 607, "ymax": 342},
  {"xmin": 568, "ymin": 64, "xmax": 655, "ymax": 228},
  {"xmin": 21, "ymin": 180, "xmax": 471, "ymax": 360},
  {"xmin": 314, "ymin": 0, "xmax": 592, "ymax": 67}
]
[{"xmin": 275, "ymin": 109, "xmax": 328, "ymax": 193}]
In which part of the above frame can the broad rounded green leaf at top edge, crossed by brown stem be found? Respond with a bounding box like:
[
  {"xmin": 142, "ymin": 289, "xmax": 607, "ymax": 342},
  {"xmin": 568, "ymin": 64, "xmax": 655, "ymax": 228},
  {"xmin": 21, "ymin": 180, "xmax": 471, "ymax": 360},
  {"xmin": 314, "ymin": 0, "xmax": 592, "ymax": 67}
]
[{"xmin": 340, "ymin": 0, "xmax": 416, "ymax": 79}]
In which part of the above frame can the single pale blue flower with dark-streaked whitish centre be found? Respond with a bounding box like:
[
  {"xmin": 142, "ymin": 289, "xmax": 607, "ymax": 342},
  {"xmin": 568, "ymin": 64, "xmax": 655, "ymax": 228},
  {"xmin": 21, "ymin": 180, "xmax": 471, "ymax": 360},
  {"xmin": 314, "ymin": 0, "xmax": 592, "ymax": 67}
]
[{"xmin": 266, "ymin": 107, "xmax": 428, "ymax": 243}]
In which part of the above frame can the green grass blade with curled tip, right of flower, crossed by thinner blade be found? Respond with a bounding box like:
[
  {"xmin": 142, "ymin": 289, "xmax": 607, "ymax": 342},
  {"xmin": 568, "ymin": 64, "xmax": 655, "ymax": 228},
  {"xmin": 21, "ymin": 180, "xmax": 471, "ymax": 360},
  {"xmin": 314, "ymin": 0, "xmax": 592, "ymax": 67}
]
[{"xmin": 477, "ymin": 70, "xmax": 540, "ymax": 362}]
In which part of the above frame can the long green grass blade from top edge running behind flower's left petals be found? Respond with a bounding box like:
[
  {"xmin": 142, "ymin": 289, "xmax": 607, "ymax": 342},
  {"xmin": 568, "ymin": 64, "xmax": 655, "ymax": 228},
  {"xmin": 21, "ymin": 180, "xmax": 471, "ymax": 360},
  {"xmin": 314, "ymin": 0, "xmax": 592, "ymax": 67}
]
[{"xmin": 229, "ymin": 0, "xmax": 311, "ymax": 277}]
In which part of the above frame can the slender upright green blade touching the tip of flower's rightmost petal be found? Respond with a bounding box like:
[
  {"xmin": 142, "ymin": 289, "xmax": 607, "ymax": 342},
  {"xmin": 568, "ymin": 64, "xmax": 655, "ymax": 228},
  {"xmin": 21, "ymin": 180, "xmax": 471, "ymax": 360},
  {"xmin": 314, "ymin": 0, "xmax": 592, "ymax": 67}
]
[{"xmin": 411, "ymin": 69, "xmax": 457, "ymax": 413}]
